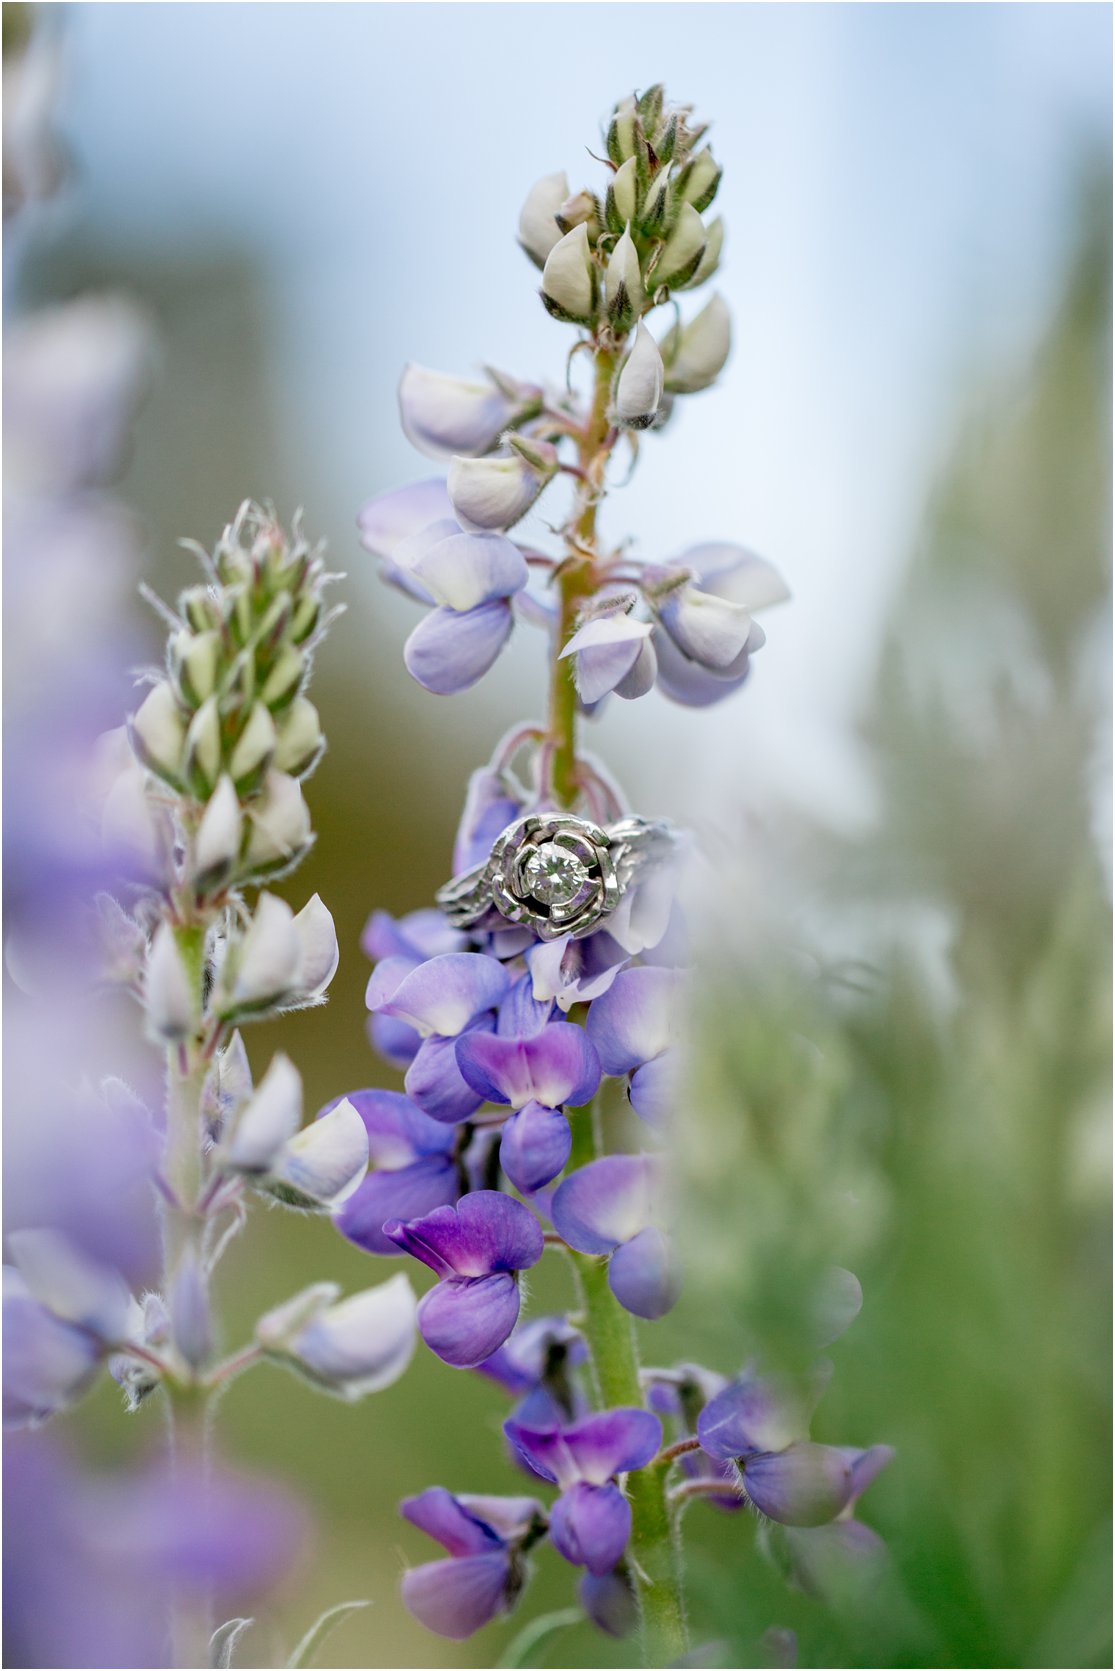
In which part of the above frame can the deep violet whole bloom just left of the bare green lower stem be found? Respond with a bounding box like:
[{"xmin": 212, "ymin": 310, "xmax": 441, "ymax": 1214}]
[{"xmin": 383, "ymin": 1190, "xmax": 543, "ymax": 1369}]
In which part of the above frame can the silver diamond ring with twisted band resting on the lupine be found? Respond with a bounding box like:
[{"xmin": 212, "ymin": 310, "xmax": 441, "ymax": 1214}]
[{"xmin": 436, "ymin": 812, "xmax": 675, "ymax": 939}]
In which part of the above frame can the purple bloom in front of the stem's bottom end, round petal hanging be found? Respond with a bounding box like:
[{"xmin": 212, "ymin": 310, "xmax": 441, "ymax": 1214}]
[{"xmin": 503, "ymin": 1409, "xmax": 662, "ymax": 1574}]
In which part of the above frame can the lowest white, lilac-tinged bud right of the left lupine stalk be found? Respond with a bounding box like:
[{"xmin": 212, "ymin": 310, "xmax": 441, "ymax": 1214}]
[{"xmin": 256, "ymin": 1273, "xmax": 416, "ymax": 1400}]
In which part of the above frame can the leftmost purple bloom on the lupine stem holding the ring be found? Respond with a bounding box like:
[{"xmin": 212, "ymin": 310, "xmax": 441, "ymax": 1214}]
[{"xmin": 323, "ymin": 1089, "xmax": 461, "ymax": 1255}]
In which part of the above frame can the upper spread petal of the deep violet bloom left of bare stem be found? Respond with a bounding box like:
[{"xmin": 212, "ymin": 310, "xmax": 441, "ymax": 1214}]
[{"xmin": 386, "ymin": 1190, "xmax": 543, "ymax": 1276}]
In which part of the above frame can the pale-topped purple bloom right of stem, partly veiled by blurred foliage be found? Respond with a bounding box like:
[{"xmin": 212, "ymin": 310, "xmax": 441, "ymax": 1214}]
[{"xmin": 550, "ymin": 1155, "xmax": 680, "ymax": 1320}]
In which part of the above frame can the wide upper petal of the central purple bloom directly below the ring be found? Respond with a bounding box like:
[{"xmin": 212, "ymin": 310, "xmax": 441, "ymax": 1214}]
[{"xmin": 456, "ymin": 1021, "xmax": 600, "ymax": 1108}]
